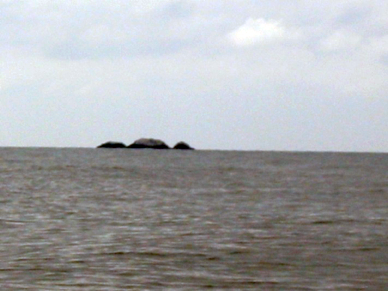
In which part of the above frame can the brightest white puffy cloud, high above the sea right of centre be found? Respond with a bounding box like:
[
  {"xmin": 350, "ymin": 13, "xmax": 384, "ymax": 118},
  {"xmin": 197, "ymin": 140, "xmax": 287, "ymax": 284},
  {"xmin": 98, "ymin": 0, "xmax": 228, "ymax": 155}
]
[{"xmin": 228, "ymin": 18, "xmax": 296, "ymax": 46}]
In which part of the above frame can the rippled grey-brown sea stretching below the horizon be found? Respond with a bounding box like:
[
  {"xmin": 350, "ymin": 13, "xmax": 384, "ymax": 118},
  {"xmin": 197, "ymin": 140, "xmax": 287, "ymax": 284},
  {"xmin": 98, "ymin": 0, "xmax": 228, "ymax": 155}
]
[{"xmin": 0, "ymin": 148, "xmax": 388, "ymax": 291}]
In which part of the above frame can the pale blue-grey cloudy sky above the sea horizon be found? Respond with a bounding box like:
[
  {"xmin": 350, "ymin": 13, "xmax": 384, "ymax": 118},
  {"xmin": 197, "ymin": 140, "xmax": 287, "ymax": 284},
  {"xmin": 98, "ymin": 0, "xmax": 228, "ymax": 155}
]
[{"xmin": 0, "ymin": 0, "xmax": 388, "ymax": 152}]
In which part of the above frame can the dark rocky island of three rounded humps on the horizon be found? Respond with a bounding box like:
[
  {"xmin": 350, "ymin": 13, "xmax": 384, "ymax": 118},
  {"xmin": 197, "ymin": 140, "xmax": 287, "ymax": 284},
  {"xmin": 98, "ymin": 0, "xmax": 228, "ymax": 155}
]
[{"xmin": 97, "ymin": 138, "xmax": 194, "ymax": 150}]
